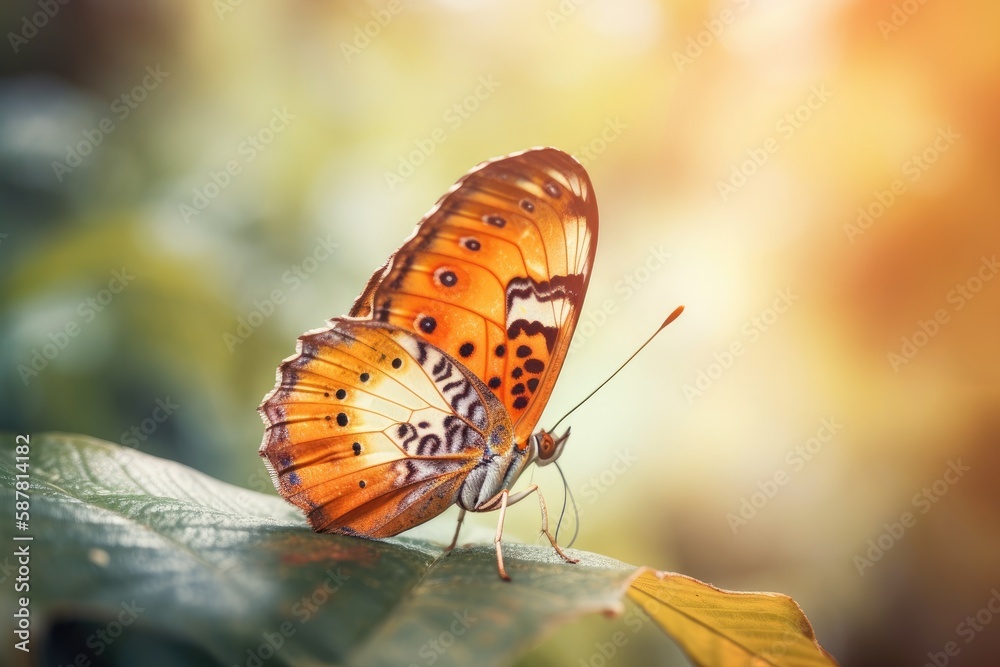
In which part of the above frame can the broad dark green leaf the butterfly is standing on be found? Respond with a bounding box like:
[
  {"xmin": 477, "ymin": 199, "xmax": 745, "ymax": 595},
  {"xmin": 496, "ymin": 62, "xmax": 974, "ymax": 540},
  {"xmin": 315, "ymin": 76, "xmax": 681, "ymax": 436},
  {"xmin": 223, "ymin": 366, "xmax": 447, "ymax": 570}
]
[{"xmin": 0, "ymin": 435, "xmax": 634, "ymax": 666}]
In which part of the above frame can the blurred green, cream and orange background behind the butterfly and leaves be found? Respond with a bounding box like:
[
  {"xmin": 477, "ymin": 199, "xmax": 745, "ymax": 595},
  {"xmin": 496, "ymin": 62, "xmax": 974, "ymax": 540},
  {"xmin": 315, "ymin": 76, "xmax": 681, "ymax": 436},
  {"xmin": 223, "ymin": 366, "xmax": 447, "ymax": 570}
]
[{"xmin": 0, "ymin": 0, "xmax": 1000, "ymax": 666}]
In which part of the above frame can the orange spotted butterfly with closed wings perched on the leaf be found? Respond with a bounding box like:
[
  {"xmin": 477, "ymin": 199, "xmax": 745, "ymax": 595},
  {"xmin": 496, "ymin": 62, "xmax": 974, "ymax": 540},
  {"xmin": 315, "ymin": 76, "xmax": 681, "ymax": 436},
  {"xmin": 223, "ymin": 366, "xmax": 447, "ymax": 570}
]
[{"xmin": 258, "ymin": 148, "xmax": 597, "ymax": 579}]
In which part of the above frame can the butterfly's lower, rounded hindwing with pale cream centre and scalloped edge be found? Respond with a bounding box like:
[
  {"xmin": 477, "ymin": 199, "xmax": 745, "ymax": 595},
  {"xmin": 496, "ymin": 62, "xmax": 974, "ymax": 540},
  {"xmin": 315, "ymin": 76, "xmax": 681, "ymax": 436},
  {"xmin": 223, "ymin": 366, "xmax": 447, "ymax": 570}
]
[{"xmin": 260, "ymin": 318, "xmax": 512, "ymax": 537}]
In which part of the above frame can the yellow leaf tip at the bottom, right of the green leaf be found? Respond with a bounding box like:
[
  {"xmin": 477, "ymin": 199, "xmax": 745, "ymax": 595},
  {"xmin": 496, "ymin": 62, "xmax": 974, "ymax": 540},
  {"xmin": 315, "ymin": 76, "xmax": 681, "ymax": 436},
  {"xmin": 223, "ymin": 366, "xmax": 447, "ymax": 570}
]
[{"xmin": 628, "ymin": 569, "xmax": 837, "ymax": 667}]
